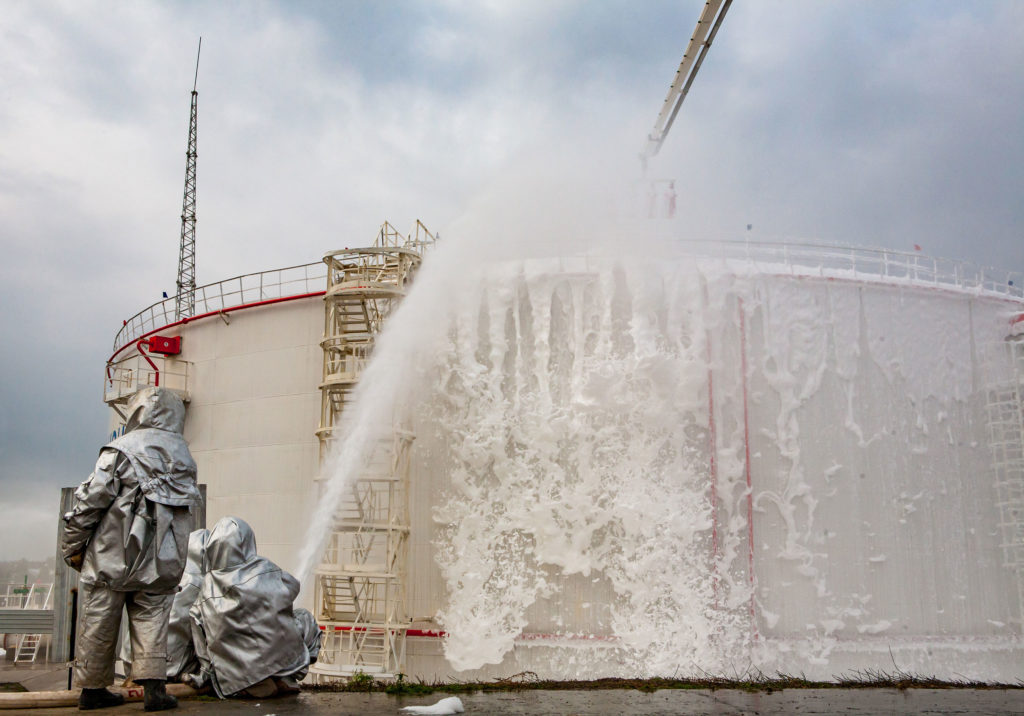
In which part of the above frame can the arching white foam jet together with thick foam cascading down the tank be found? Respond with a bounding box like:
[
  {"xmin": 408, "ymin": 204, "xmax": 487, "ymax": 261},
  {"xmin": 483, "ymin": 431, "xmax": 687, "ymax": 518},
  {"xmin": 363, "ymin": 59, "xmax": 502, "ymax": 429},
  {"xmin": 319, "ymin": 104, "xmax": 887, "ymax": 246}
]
[{"xmin": 299, "ymin": 148, "xmax": 750, "ymax": 673}]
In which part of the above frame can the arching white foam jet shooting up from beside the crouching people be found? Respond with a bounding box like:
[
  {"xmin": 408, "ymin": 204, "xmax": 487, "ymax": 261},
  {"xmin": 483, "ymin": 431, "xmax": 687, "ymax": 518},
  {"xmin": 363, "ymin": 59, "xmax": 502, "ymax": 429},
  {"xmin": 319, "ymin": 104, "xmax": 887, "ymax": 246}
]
[{"xmin": 298, "ymin": 144, "xmax": 638, "ymax": 584}]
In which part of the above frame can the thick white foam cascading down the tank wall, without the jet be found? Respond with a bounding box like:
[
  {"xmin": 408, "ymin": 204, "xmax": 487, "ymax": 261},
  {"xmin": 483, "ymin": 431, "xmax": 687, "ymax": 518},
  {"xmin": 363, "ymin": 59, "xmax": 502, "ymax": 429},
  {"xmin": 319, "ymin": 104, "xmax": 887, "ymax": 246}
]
[{"xmin": 411, "ymin": 261, "xmax": 751, "ymax": 675}]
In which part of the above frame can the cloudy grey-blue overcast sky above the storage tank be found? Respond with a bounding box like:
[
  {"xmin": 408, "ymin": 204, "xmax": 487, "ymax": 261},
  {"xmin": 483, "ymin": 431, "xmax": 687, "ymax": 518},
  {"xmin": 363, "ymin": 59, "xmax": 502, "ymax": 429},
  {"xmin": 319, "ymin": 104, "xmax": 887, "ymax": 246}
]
[{"xmin": 0, "ymin": 0, "xmax": 1024, "ymax": 559}]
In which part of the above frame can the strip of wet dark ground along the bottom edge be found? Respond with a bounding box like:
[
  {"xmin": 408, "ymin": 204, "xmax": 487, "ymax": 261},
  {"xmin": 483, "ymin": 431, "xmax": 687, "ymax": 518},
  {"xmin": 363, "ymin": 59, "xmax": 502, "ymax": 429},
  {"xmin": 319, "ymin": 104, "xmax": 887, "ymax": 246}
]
[{"xmin": 6, "ymin": 688, "xmax": 1024, "ymax": 716}]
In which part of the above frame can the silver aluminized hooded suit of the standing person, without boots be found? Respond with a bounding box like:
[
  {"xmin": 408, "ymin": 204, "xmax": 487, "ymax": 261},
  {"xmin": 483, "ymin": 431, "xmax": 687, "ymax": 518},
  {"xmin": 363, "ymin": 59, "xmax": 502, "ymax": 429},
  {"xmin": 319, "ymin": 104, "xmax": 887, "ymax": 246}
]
[{"xmin": 61, "ymin": 387, "xmax": 202, "ymax": 688}]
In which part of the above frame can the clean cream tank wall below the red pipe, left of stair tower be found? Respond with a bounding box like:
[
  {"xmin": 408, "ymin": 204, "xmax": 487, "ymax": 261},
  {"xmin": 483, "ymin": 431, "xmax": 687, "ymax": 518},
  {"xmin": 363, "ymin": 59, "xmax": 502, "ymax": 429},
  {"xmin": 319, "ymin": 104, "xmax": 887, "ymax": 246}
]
[{"xmin": 105, "ymin": 296, "xmax": 324, "ymax": 571}]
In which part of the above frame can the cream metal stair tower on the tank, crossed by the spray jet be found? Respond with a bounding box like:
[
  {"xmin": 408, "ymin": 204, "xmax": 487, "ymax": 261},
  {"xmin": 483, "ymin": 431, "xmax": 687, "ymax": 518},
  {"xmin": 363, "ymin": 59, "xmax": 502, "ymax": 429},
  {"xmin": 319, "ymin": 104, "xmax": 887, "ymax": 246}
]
[{"xmin": 310, "ymin": 221, "xmax": 436, "ymax": 681}]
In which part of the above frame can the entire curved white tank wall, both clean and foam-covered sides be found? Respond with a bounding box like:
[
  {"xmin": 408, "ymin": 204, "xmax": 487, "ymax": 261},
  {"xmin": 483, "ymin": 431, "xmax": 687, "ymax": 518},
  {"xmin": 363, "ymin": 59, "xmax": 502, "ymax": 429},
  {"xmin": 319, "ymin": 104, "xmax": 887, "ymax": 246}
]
[{"xmin": 105, "ymin": 249, "xmax": 1024, "ymax": 680}]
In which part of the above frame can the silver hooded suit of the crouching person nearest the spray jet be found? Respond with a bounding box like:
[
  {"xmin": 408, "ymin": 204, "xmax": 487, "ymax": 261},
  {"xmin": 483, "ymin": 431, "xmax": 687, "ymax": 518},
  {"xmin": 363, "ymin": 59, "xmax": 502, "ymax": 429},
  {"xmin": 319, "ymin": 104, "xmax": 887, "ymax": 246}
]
[{"xmin": 188, "ymin": 517, "xmax": 309, "ymax": 698}]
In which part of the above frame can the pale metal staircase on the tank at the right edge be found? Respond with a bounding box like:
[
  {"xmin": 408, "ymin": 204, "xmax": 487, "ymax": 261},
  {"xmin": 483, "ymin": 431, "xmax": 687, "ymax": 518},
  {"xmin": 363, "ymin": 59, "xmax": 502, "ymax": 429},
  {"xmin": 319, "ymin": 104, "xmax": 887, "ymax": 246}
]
[{"xmin": 986, "ymin": 335, "xmax": 1024, "ymax": 632}]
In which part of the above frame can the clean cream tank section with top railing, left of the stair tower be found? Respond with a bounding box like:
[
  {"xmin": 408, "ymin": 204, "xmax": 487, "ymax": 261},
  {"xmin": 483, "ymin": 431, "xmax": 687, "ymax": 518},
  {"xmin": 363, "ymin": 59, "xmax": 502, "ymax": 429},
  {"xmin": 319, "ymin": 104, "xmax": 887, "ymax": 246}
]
[{"xmin": 104, "ymin": 262, "xmax": 326, "ymax": 571}]
